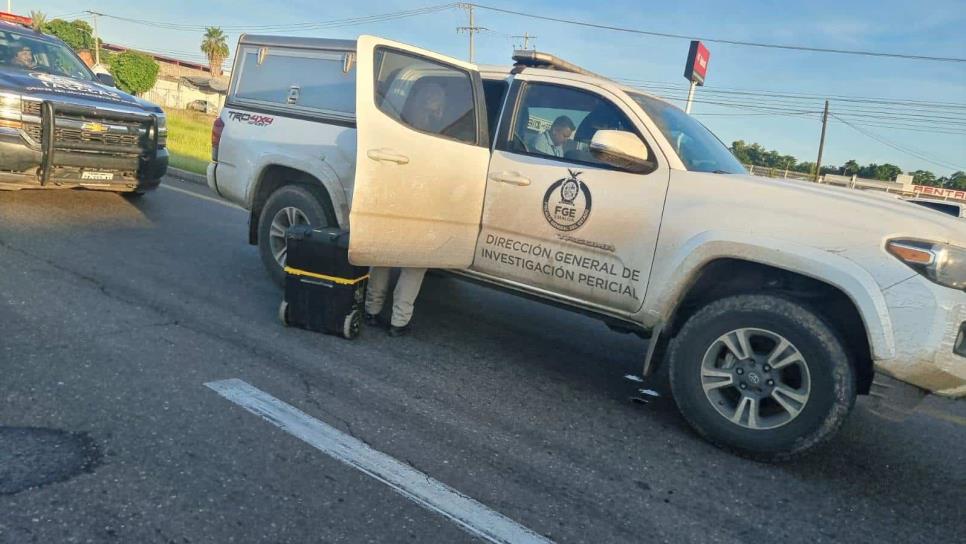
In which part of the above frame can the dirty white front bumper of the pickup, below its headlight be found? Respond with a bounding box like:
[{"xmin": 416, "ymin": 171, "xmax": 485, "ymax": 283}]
[{"xmin": 875, "ymin": 276, "xmax": 966, "ymax": 398}]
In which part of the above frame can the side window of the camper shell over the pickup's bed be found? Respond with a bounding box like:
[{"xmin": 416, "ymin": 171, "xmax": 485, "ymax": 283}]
[{"xmin": 234, "ymin": 47, "xmax": 356, "ymax": 114}]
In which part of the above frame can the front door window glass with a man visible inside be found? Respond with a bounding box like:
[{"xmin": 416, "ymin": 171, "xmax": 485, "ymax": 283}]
[{"xmin": 499, "ymin": 83, "xmax": 646, "ymax": 168}]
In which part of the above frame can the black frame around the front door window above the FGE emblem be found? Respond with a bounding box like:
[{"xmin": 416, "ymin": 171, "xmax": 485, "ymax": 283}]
[{"xmin": 495, "ymin": 80, "xmax": 660, "ymax": 175}]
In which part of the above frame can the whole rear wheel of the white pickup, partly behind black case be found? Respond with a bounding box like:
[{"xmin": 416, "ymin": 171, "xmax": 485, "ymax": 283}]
[{"xmin": 258, "ymin": 185, "xmax": 329, "ymax": 286}]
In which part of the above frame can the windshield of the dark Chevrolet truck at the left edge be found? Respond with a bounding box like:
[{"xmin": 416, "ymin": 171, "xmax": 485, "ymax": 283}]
[{"xmin": 0, "ymin": 31, "xmax": 94, "ymax": 81}]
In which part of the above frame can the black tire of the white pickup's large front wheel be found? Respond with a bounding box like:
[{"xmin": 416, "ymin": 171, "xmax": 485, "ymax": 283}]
[{"xmin": 668, "ymin": 295, "xmax": 856, "ymax": 461}]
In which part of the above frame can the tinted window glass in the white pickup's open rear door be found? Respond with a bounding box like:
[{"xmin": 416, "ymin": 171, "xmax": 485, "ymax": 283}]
[{"xmin": 373, "ymin": 48, "xmax": 477, "ymax": 144}]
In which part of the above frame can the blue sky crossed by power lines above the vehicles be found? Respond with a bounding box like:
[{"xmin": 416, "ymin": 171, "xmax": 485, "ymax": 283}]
[{"xmin": 12, "ymin": 0, "xmax": 966, "ymax": 175}]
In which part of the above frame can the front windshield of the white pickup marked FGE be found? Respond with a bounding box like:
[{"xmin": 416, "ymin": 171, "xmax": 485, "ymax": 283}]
[{"xmin": 627, "ymin": 93, "xmax": 747, "ymax": 174}]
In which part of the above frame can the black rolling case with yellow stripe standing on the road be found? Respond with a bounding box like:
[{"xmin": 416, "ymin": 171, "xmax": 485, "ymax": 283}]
[{"xmin": 278, "ymin": 225, "xmax": 369, "ymax": 338}]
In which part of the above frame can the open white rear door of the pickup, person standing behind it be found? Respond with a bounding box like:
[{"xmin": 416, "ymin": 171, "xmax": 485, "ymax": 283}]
[{"xmin": 349, "ymin": 36, "xmax": 490, "ymax": 268}]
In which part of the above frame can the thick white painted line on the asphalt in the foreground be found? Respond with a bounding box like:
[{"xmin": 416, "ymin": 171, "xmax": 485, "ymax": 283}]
[{"xmin": 205, "ymin": 379, "xmax": 552, "ymax": 544}]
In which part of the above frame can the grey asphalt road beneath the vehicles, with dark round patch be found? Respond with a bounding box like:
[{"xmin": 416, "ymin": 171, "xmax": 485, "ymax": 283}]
[{"xmin": 0, "ymin": 181, "xmax": 966, "ymax": 544}]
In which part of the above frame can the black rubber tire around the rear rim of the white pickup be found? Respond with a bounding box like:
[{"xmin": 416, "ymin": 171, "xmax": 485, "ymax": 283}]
[{"xmin": 258, "ymin": 185, "xmax": 334, "ymax": 287}]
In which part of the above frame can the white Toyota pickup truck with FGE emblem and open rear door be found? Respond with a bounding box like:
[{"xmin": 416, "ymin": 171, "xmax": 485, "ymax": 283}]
[{"xmin": 208, "ymin": 36, "xmax": 966, "ymax": 460}]
